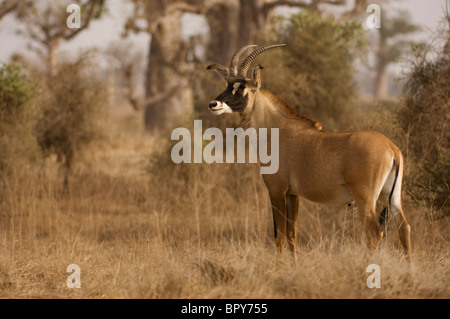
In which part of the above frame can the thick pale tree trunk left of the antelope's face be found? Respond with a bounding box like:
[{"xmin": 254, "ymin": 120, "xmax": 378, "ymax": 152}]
[{"xmin": 121, "ymin": 0, "xmax": 201, "ymax": 129}]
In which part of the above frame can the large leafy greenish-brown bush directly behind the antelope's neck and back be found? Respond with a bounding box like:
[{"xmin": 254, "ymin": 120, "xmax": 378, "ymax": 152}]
[{"xmin": 260, "ymin": 11, "xmax": 367, "ymax": 130}]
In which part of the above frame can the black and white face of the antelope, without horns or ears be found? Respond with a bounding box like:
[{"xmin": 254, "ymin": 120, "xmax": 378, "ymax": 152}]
[{"xmin": 209, "ymin": 81, "xmax": 248, "ymax": 115}]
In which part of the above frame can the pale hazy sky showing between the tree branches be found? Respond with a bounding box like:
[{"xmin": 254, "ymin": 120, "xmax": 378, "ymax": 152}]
[{"xmin": 0, "ymin": 0, "xmax": 445, "ymax": 62}]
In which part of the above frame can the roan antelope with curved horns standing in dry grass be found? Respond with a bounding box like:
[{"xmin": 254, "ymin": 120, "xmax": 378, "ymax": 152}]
[{"xmin": 208, "ymin": 44, "xmax": 411, "ymax": 261}]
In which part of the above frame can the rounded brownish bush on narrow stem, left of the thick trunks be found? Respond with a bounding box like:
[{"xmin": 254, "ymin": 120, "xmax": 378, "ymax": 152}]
[{"xmin": 36, "ymin": 55, "xmax": 107, "ymax": 186}]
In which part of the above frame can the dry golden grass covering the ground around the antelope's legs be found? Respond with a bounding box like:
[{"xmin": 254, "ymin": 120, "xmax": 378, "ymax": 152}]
[{"xmin": 0, "ymin": 107, "xmax": 450, "ymax": 298}]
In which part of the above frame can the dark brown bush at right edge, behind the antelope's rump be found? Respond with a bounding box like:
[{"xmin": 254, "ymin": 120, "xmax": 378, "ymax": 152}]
[{"xmin": 399, "ymin": 30, "xmax": 450, "ymax": 215}]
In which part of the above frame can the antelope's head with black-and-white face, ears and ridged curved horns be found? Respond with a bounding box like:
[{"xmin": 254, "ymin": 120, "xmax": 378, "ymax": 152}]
[{"xmin": 207, "ymin": 44, "xmax": 284, "ymax": 115}]
